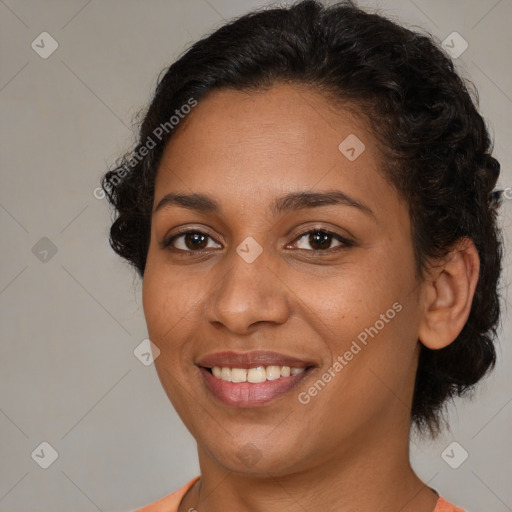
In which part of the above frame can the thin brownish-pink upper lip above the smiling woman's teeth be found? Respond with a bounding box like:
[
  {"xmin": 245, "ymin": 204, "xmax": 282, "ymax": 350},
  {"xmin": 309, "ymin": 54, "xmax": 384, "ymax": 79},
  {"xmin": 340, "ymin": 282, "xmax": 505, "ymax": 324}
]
[{"xmin": 196, "ymin": 350, "xmax": 314, "ymax": 368}]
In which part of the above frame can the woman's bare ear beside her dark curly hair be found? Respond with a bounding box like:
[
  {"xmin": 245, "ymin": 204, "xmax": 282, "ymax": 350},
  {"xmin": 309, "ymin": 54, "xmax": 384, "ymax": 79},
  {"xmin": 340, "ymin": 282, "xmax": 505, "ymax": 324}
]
[{"xmin": 418, "ymin": 238, "xmax": 480, "ymax": 350}]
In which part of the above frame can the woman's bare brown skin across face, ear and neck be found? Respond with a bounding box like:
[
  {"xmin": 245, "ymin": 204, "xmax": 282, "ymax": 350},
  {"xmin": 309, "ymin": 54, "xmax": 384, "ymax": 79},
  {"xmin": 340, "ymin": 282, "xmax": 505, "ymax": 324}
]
[{"xmin": 143, "ymin": 84, "xmax": 478, "ymax": 512}]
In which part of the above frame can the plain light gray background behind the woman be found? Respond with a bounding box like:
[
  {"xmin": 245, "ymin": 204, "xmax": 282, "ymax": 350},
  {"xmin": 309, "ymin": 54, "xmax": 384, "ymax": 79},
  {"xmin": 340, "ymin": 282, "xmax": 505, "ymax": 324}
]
[{"xmin": 0, "ymin": 0, "xmax": 512, "ymax": 512}]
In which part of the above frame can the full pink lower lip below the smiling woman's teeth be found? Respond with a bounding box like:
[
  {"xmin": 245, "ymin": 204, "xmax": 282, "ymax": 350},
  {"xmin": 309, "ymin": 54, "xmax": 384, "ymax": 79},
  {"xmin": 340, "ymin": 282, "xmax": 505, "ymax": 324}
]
[{"xmin": 200, "ymin": 367, "xmax": 314, "ymax": 407}]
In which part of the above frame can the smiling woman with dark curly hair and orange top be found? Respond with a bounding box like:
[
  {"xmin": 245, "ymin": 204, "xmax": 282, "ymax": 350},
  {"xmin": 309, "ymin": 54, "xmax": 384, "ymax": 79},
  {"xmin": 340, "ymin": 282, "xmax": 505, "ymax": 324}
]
[{"xmin": 103, "ymin": 1, "xmax": 502, "ymax": 512}]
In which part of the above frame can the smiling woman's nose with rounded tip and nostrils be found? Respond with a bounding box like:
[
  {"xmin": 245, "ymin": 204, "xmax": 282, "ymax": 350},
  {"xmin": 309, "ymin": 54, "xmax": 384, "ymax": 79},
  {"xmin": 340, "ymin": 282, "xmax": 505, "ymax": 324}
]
[{"xmin": 206, "ymin": 246, "xmax": 290, "ymax": 334}]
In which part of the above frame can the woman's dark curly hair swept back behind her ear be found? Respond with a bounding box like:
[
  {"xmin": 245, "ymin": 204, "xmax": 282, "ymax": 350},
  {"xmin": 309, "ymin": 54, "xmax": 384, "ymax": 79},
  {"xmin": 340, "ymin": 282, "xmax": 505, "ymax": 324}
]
[{"xmin": 102, "ymin": 0, "xmax": 503, "ymax": 437}]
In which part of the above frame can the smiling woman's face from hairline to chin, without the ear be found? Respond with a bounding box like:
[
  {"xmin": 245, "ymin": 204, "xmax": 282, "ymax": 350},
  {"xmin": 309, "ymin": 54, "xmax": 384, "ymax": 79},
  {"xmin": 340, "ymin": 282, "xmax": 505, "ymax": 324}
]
[{"xmin": 143, "ymin": 85, "xmax": 421, "ymax": 475}]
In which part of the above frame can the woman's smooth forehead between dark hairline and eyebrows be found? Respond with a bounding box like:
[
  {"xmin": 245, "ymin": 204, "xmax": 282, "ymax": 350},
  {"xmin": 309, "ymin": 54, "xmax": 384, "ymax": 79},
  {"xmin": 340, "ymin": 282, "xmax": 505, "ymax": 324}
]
[{"xmin": 155, "ymin": 84, "xmax": 404, "ymax": 220}]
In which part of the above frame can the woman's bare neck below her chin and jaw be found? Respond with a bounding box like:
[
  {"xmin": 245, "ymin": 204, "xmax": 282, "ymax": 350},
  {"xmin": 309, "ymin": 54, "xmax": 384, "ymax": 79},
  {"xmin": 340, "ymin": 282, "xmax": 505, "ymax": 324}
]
[{"xmin": 179, "ymin": 416, "xmax": 438, "ymax": 512}]
